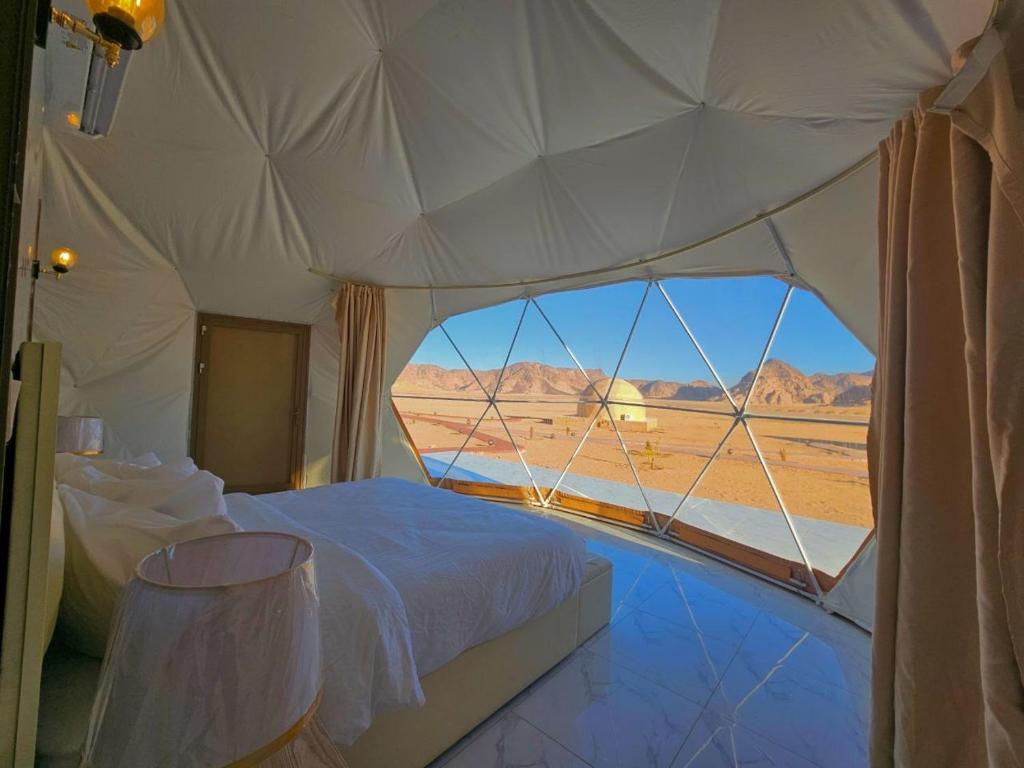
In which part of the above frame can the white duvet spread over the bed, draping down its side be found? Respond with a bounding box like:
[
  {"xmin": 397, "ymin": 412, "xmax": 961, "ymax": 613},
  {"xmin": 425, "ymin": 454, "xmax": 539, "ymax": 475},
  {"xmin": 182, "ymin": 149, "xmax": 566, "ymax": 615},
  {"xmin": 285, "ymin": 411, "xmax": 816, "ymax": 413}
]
[{"xmin": 225, "ymin": 478, "xmax": 585, "ymax": 743}]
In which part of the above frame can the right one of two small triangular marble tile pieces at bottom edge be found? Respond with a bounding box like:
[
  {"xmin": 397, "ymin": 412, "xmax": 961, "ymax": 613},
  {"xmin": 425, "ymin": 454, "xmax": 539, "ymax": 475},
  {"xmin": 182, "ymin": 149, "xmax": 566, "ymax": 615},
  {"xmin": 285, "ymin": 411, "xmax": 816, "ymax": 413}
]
[{"xmin": 672, "ymin": 712, "xmax": 818, "ymax": 768}]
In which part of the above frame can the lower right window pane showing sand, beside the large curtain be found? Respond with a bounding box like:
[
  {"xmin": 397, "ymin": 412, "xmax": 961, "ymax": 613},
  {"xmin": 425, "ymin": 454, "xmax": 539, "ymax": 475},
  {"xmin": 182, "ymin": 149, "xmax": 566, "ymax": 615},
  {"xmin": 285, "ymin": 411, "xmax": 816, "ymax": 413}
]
[{"xmin": 751, "ymin": 419, "xmax": 874, "ymax": 575}]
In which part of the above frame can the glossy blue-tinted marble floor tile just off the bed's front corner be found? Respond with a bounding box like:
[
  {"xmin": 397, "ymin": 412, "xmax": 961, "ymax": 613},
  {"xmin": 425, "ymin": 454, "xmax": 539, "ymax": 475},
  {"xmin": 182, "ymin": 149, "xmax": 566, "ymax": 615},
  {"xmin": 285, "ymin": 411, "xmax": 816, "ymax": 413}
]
[{"xmin": 585, "ymin": 609, "xmax": 742, "ymax": 705}]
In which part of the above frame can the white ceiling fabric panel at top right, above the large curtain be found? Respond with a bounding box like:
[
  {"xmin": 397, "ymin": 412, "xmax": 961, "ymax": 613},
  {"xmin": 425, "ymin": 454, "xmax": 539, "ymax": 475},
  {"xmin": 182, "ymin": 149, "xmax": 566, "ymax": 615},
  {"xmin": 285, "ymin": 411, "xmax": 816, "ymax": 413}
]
[{"xmin": 707, "ymin": 0, "xmax": 991, "ymax": 122}]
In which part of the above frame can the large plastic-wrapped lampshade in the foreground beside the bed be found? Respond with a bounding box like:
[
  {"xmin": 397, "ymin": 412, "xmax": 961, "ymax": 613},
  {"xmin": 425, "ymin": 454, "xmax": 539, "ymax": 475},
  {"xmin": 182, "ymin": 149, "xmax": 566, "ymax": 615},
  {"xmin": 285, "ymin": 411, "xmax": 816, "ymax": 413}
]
[{"xmin": 83, "ymin": 532, "xmax": 322, "ymax": 768}]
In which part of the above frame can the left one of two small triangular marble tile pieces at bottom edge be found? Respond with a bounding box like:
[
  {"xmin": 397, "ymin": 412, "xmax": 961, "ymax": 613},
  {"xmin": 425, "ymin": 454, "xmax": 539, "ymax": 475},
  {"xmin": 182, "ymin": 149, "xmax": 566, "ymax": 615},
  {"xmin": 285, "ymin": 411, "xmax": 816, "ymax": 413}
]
[{"xmin": 433, "ymin": 713, "xmax": 590, "ymax": 768}]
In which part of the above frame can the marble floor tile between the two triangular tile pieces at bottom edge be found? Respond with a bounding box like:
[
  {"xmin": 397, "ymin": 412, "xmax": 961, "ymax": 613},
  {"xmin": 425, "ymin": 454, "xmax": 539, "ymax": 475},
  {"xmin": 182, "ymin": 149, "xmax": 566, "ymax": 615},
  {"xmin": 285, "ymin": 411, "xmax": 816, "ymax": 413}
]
[{"xmin": 515, "ymin": 651, "xmax": 700, "ymax": 768}]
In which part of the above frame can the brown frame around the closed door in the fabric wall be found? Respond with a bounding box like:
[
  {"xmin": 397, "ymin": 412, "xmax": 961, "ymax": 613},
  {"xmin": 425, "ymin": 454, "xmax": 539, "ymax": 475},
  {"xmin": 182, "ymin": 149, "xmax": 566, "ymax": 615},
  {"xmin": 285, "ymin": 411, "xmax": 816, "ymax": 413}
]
[{"xmin": 188, "ymin": 312, "xmax": 310, "ymax": 494}]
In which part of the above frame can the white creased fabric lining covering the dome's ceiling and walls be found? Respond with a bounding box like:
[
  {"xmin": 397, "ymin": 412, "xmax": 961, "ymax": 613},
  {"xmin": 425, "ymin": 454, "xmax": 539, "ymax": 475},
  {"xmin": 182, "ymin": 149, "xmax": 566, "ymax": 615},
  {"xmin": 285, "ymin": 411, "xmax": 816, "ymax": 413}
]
[{"xmin": 19, "ymin": 0, "xmax": 990, "ymax": 623}]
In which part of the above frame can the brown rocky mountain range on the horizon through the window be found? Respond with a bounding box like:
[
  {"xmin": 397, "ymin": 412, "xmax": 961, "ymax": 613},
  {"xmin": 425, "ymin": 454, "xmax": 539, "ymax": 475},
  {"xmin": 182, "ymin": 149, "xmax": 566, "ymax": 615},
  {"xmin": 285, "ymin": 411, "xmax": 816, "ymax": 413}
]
[{"xmin": 392, "ymin": 358, "xmax": 871, "ymax": 406}]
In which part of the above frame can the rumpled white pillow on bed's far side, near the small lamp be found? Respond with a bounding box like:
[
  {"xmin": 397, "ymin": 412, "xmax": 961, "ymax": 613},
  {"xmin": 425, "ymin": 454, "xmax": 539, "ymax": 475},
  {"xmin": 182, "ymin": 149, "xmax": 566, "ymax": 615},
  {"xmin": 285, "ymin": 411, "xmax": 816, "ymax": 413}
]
[{"xmin": 63, "ymin": 459, "xmax": 227, "ymax": 520}]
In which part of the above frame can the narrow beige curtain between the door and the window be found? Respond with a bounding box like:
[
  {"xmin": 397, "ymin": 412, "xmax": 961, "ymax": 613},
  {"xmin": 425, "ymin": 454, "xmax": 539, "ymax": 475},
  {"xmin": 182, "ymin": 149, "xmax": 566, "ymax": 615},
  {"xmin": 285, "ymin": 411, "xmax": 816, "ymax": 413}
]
[{"xmin": 331, "ymin": 283, "xmax": 387, "ymax": 482}]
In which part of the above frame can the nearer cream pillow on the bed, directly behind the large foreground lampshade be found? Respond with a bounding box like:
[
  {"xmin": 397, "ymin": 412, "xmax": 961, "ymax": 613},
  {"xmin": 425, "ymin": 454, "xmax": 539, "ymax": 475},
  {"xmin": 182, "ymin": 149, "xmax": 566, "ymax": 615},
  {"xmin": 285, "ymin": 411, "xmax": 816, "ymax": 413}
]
[{"xmin": 58, "ymin": 485, "xmax": 240, "ymax": 658}]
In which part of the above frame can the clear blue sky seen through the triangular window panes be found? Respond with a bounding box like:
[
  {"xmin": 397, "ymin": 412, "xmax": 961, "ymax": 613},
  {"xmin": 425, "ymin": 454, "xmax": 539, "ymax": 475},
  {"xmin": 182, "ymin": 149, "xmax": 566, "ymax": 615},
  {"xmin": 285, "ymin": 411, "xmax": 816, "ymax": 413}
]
[{"xmin": 413, "ymin": 278, "xmax": 874, "ymax": 386}]
